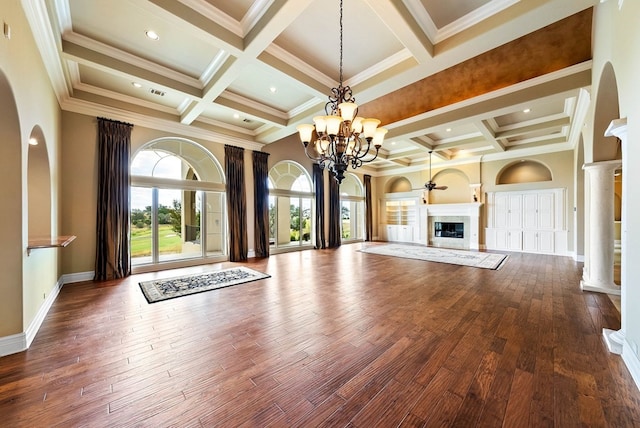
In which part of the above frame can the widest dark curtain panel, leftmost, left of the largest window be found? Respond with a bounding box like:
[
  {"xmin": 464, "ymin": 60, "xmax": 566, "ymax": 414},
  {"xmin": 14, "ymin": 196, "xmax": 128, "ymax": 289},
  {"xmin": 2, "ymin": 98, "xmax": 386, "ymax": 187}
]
[{"xmin": 94, "ymin": 118, "xmax": 133, "ymax": 281}]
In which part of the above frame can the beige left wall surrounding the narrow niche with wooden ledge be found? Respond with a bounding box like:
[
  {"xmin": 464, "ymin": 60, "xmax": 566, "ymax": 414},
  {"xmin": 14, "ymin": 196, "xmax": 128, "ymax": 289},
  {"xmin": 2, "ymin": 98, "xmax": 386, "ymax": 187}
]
[{"xmin": 0, "ymin": 0, "xmax": 61, "ymax": 337}]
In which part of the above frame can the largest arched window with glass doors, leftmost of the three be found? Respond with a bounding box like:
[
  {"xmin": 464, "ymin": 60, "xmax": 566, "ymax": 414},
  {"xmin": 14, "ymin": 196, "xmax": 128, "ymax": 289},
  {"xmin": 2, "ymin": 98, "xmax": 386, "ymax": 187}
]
[{"xmin": 130, "ymin": 138, "xmax": 227, "ymax": 271}]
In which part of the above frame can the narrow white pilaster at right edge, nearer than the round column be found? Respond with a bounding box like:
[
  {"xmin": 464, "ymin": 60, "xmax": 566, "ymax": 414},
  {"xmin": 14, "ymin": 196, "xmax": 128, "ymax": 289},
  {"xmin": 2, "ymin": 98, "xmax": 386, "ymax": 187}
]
[{"xmin": 602, "ymin": 118, "xmax": 629, "ymax": 355}]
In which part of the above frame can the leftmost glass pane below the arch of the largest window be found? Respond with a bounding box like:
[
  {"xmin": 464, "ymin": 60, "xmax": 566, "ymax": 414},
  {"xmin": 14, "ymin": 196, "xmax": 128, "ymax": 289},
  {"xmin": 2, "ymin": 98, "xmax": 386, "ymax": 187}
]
[{"xmin": 130, "ymin": 187, "xmax": 153, "ymax": 265}]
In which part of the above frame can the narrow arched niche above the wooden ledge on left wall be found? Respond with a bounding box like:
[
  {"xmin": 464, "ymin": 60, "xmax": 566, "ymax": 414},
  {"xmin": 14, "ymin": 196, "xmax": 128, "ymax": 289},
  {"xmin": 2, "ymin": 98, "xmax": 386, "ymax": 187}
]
[{"xmin": 27, "ymin": 125, "xmax": 51, "ymax": 238}]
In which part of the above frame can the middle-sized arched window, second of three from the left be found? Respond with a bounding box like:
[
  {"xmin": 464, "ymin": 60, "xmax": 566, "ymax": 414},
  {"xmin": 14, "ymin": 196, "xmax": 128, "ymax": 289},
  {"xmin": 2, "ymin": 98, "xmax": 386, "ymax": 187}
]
[{"xmin": 269, "ymin": 161, "xmax": 313, "ymax": 252}]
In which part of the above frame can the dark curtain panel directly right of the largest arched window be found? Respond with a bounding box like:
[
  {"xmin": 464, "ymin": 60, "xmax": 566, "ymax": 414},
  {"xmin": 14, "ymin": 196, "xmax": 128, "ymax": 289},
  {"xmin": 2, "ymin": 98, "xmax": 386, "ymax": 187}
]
[{"xmin": 224, "ymin": 145, "xmax": 249, "ymax": 262}]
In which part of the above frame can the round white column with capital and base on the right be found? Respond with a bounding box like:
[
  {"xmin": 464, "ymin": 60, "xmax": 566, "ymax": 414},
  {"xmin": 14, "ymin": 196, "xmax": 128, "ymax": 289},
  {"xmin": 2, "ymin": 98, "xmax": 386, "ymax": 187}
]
[{"xmin": 580, "ymin": 160, "xmax": 622, "ymax": 294}]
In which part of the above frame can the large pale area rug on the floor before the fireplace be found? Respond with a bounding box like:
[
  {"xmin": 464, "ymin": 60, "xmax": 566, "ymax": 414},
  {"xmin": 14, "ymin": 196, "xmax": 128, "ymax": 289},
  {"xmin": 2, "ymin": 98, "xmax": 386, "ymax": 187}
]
[{"xmin": 360, "ymin": 244, "xmax": 507, "ymax": 269}]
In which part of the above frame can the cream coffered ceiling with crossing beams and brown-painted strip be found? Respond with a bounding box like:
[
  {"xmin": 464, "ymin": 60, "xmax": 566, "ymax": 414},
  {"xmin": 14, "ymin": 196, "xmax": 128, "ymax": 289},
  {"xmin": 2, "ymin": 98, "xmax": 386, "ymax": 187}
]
[{"xmin": 23, "ymin": 0, "xmax": 596, "ymax": 174}]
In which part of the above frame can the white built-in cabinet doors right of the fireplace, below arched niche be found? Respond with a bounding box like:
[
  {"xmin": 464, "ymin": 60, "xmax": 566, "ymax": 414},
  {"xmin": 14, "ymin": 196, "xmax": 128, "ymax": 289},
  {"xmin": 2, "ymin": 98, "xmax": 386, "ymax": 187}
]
[{"xmin": 485, "ymin": 189, "xmax": 568, "ymax": 254}]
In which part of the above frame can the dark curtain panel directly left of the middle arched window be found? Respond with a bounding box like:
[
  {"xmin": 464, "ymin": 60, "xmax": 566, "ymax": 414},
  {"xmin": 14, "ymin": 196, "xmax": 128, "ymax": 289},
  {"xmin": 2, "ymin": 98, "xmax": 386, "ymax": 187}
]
[{"xmin": 253, "ymin": 151, "xmax": 269, "ymax": 257}]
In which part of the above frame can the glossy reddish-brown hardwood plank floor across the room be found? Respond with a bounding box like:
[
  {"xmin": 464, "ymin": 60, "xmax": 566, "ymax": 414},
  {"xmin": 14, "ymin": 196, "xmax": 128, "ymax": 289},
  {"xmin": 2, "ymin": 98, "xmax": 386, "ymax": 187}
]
[{"xmin": 0, "ymin": 244, "xmax": 640, "ymax": 428}]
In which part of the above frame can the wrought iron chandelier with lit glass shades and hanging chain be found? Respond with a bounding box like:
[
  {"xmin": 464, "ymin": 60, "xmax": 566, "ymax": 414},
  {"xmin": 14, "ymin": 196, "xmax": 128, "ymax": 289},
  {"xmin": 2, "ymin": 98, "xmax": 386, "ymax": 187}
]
[{"xmin": 297, "ymin": 0, "xmax": 387, "ymax": 183}]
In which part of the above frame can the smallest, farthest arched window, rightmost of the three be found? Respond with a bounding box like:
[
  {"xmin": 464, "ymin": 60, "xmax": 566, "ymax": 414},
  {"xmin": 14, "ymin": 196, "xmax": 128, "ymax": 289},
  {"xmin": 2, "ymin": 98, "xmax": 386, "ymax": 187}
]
[{"xmin": 340, "ymin": 173, "xmax": 364, "ymax": 241}]
